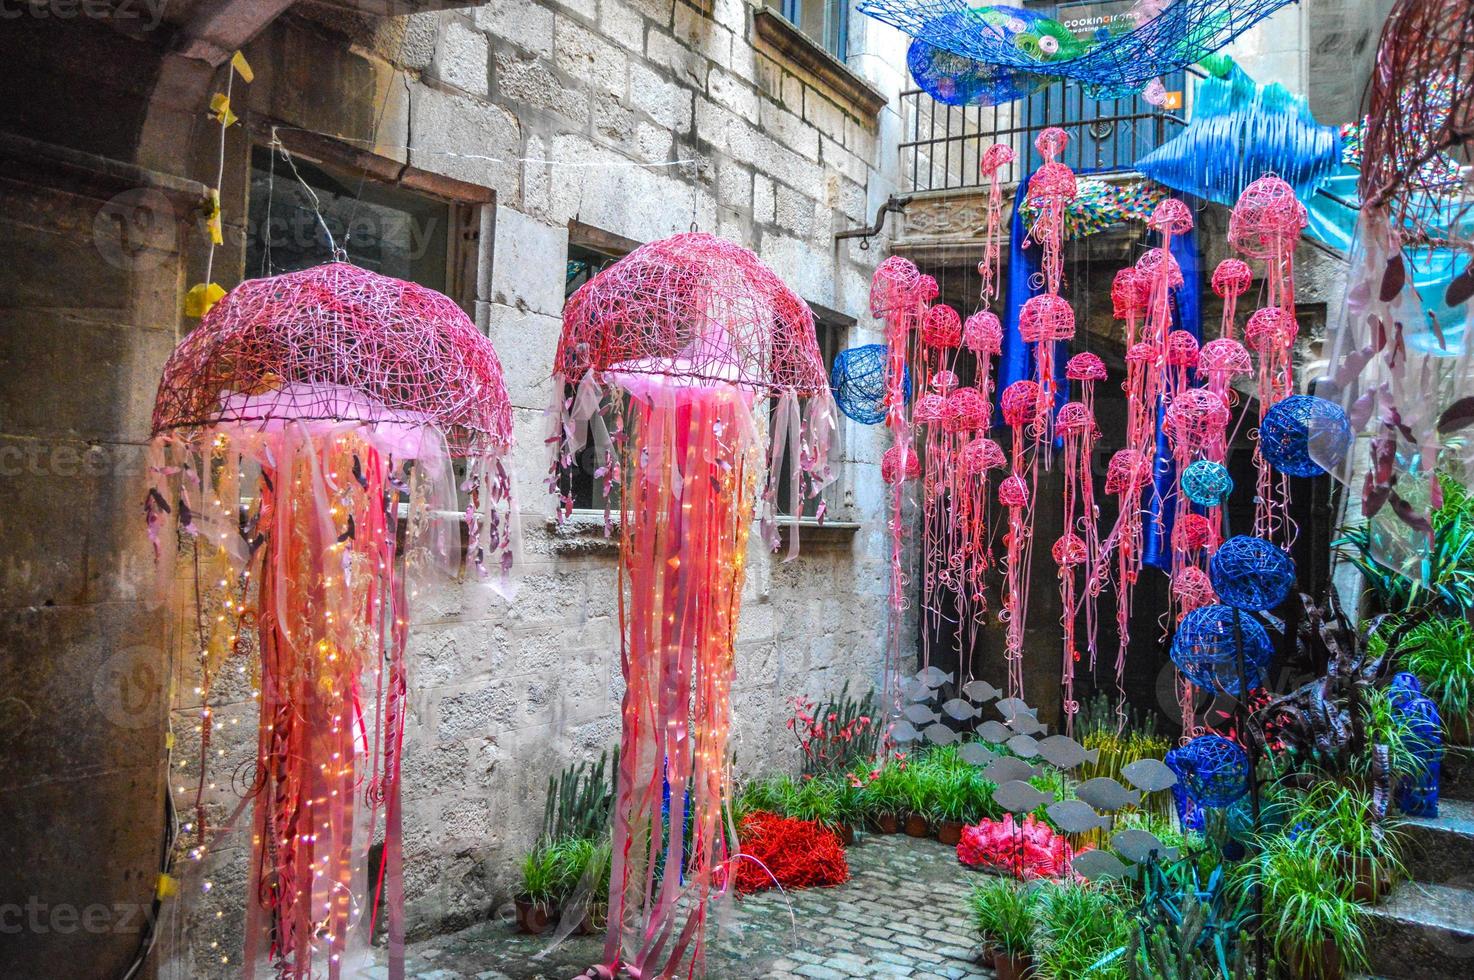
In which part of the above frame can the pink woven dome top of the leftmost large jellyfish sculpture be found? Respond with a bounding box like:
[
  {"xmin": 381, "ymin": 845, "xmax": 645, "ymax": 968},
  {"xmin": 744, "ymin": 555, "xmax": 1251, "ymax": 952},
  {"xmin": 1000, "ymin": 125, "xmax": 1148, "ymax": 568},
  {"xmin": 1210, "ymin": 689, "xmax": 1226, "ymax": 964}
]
[{"xmin": 153, "ymin": 262, "xmax": 511, "ymax": 455}]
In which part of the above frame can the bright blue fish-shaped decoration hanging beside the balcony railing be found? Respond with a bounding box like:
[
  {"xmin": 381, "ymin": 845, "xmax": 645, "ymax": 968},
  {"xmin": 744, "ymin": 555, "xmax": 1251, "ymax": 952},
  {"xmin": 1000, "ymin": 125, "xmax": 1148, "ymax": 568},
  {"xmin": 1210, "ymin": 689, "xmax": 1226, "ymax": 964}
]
[{"xmin": 1135, "ymin": 66, "xmax": 1341, "ymax": 205}]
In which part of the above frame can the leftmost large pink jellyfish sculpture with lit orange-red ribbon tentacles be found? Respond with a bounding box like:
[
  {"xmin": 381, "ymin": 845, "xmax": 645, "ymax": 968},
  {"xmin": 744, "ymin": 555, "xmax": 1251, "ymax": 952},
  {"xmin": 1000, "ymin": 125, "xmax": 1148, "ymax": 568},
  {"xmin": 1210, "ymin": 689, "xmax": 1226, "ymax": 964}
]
[{"xmin": 144, "ymin": 262, "xmax": 516, "ymax": 979}]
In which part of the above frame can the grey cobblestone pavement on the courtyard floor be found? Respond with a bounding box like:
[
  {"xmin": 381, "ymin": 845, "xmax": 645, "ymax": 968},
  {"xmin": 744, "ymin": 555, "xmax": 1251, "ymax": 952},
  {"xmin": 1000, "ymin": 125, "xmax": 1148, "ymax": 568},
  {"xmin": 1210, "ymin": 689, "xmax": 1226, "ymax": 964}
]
[{"xmin": 395, "ymin": 834, "xmax": 993, "ymax": 980}]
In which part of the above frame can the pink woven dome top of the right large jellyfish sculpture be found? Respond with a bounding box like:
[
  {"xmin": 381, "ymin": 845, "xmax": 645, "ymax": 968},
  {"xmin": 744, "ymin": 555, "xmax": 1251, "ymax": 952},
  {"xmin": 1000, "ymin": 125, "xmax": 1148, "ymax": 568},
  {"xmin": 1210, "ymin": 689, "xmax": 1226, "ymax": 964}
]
[{"xmin": 554, "ymin": 231, "xmax": 828, "ymax": 395}]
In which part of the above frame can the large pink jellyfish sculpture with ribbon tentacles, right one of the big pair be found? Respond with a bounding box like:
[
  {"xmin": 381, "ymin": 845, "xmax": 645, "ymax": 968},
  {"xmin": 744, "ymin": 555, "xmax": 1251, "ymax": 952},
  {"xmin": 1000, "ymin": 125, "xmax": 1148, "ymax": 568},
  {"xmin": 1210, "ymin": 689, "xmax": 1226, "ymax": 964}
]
[{"xmin": 550, "ymin": 233, "xmax": 831, "ymax": 977}]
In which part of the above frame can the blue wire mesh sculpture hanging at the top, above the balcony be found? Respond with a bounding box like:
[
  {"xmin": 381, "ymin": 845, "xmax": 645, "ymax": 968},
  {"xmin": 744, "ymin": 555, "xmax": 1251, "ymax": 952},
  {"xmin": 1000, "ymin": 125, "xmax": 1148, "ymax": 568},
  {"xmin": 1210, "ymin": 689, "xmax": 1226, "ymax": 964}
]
[{"xmin": 859, "ymin": 0, "xmax": 1290, "ymax": 94}]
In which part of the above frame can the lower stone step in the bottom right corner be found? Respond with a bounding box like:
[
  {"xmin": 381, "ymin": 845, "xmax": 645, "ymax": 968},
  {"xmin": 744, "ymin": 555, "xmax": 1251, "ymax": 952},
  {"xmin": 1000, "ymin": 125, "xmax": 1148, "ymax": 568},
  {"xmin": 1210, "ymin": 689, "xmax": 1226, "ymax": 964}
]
[{"xmin": 1366, "ymin": 881, "xmax": 1474, "ymax": 980}]
